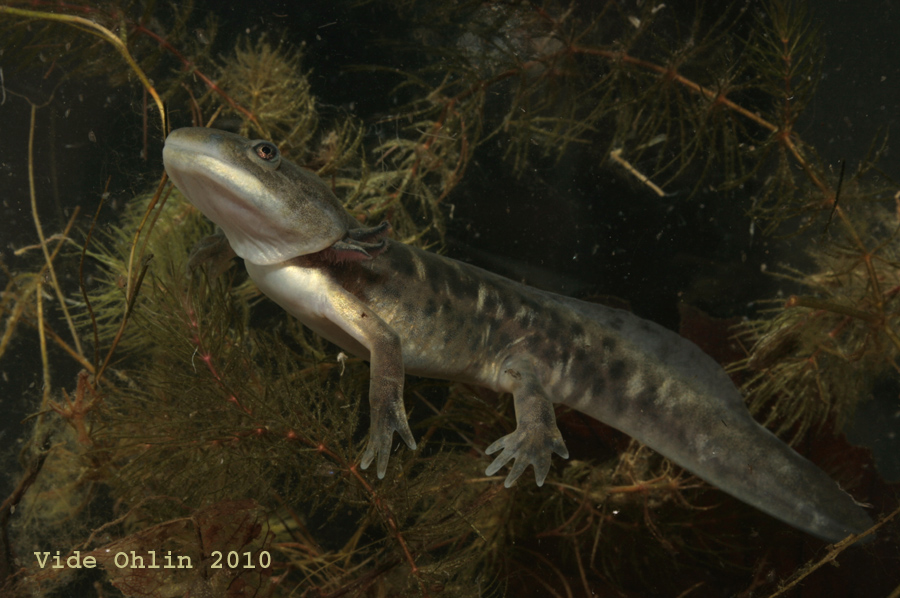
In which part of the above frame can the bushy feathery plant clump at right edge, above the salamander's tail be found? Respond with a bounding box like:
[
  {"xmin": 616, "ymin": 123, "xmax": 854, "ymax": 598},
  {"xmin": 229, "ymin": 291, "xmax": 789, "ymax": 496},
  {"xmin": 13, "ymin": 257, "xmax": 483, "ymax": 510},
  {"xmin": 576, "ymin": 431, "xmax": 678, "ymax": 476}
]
[{"xmin": 741, "ymin": 204, "xmax": 900, "ymax": 441}]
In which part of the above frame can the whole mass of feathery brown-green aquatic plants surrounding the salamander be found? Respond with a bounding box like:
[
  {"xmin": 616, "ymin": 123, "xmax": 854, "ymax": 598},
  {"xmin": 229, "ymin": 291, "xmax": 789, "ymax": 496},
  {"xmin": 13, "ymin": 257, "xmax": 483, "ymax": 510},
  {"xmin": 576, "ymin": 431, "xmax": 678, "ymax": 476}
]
[{"xmin": 0, "ymin": 0, "xmax": 900, "ymax": 597}]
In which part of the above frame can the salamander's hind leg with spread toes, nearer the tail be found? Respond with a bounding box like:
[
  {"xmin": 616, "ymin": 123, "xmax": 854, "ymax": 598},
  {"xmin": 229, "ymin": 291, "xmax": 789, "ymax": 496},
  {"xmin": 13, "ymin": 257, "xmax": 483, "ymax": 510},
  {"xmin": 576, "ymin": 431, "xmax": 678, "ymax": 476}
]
[{"xmin": 485, "ymin": 366, "xmax": 569, "ymax": 488}]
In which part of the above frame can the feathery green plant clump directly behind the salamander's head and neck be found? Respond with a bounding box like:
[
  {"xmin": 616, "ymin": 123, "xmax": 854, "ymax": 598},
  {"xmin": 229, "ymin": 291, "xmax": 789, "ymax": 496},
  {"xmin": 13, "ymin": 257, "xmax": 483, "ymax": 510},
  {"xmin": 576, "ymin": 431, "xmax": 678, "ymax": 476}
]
[{"xmin": 205, "ymin": 37, "xmax": 443, "ymax": 242}]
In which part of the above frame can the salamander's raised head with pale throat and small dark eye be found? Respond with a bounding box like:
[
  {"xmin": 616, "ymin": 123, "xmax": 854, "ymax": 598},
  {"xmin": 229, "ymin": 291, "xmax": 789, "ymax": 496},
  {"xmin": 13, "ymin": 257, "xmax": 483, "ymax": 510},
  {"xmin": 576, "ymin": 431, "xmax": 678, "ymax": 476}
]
[{"xmin": 163, "ymin": 127, "xmax": 358, "ymax": 265}]
